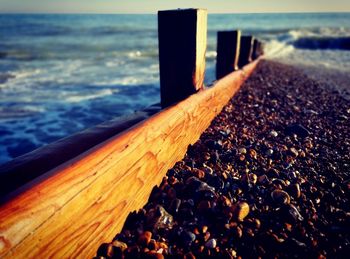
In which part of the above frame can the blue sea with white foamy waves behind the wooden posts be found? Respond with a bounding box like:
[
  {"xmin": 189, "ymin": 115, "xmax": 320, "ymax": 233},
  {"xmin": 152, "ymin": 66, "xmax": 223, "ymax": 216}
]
[{"xmin": 0, "ymin": 13, "xmax": 350, "ymax": 164}]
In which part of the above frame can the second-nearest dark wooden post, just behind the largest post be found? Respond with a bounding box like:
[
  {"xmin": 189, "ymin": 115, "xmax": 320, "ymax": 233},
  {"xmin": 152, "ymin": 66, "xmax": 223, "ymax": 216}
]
[{"xmin": 216, "ymin": 30, "xmax": 241, "ymax": 79}]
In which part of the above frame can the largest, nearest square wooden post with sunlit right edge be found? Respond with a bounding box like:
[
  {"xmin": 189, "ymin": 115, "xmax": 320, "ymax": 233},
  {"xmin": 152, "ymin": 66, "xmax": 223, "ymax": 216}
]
[{"xmin": 158, "ymin": 9, "xmax": 207, "ymax": 108}]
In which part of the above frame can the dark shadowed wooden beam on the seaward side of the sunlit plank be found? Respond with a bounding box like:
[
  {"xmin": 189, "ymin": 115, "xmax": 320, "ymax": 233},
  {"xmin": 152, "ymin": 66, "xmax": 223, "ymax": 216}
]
[{"xmin": 0, "ymin": 105, "xmax": 160, "ymax": 200}]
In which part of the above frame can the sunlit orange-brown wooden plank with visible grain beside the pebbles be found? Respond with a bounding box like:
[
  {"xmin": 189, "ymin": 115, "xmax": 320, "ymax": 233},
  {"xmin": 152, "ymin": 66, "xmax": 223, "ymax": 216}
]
[{"xmin": 0, "ymin": 61, "xmax": 258, "ymax": 258}]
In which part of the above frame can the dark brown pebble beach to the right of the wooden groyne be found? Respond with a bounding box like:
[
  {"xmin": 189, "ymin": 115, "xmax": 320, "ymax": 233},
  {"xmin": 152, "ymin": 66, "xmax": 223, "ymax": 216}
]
[{"xmin": 96, "ymin": 60, "xmax": 350, "ymax": 258}]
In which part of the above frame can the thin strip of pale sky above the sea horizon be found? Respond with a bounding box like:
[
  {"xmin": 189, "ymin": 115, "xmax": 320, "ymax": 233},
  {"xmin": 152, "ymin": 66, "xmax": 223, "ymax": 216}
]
[{"xmin": 0, "ymin": 0, "xmax": 350, "ymax": 13}]
